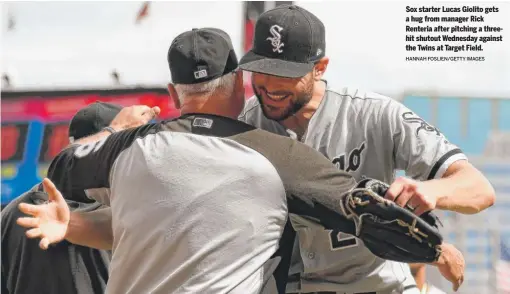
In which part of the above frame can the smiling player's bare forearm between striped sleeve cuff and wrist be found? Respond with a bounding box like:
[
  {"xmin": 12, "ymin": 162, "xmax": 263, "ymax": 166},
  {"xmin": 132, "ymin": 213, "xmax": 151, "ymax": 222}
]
[{"xmin": 429, "ymin": 162, "xmax": 496, "ymax": 214}]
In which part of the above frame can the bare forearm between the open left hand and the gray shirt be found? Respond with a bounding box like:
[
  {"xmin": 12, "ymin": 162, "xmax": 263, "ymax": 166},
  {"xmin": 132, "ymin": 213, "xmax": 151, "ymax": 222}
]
[{"xmin": 66, "ymin": 208, "xmax": 113, "ymax": 250}]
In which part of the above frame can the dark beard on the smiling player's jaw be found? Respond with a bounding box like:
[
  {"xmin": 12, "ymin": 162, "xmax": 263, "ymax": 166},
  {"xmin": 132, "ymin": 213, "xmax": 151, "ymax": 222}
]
[{"xmin": 251, "ymin": 79, "xmax": 315, "ymax": 121}]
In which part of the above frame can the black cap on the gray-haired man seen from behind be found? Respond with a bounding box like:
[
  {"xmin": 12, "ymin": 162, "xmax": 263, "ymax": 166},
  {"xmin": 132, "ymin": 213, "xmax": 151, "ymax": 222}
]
[{"xmin": 168, "ymin": 28, "xmax": 238, "ymax": 84}]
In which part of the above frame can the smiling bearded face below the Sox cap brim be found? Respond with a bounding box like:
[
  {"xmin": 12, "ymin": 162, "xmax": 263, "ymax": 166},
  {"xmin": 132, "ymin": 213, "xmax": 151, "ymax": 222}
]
[{"xmin": 251, "ymin": 72, "xmax": 314, "ymax": 121}]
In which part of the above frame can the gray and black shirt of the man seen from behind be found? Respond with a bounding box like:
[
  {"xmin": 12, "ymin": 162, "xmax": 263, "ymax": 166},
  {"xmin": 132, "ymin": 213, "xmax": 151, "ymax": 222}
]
[{"xmin": 50, "ymin": 114, "xmax": 362, "ymax": 294}]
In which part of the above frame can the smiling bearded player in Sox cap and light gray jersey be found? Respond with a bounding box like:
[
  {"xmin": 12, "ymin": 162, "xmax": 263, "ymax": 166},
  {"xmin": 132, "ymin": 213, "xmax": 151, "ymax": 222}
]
[{"xmin": 239, "ymin": 5, "xmax": 495, "ymax": 294}]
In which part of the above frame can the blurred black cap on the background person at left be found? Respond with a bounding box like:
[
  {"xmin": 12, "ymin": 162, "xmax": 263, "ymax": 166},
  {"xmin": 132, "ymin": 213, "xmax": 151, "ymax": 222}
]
[{"xmin": 69, "ymin": 101, "xmax": 122, "ymax": 143}]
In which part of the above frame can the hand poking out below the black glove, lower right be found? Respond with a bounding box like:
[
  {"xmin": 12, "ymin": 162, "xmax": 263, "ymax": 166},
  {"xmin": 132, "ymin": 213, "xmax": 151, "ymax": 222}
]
[{"xmin": 435, "ymin": 243, "xmax": 466, "ymax": 291}]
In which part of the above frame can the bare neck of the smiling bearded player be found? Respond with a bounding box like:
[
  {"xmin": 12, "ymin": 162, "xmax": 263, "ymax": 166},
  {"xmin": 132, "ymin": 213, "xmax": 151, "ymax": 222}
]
[{"xmin": 281, "ymin": 80, "xmax": 326, "ymax": 138}]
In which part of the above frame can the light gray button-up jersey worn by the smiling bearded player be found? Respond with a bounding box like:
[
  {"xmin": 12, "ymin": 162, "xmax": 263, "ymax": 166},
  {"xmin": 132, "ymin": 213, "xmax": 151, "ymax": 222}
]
[{"xmin": 239, "ymin": 87, "xmax": 466, "ymax": 293}]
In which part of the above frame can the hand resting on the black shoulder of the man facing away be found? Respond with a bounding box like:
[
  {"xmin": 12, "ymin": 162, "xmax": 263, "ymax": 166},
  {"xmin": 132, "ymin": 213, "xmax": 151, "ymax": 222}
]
[{"xmin": 110, "ymin": 105, "xmax": 161, "ymax": 131}]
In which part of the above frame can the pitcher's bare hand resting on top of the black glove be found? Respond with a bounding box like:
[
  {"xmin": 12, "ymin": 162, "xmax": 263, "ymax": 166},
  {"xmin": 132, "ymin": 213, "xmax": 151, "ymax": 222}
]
[{"xmin": 385, "ymin": 177, "xmax": 437, "ymax": 215}]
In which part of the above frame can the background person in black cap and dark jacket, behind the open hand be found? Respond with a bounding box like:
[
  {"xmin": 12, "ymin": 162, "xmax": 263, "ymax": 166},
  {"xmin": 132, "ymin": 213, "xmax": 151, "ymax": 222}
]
[{"xmin": 2, "ymin": 102, "xmax": 122, "ymax": 294}]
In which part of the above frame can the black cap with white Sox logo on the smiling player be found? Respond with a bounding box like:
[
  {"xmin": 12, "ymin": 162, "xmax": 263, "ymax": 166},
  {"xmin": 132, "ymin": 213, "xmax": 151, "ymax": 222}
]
[{"xmin": 239, "ymin": 5, "xmax": 326, "ymax": 78}]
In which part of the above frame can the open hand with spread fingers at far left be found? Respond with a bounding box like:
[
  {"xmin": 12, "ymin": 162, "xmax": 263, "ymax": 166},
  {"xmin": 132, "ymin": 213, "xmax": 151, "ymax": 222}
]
[{"xmin": 16, "ymin": 179, "xmax": 71, "ymax": 250}]
